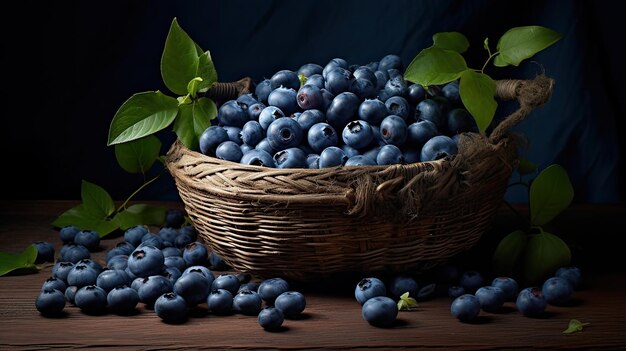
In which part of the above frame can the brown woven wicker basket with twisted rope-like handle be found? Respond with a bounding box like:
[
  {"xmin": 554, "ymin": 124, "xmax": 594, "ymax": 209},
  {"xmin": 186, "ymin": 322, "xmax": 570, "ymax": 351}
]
[{"xmin": 167, "ymin": 76, "xmax": 553, "ymax": 281}]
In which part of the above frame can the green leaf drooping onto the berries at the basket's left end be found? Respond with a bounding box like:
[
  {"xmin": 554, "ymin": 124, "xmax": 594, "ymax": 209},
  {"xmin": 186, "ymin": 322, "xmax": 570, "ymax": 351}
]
[{"xmin": 174, "ymin": 98, "xmax": 217, "ymax": 150}]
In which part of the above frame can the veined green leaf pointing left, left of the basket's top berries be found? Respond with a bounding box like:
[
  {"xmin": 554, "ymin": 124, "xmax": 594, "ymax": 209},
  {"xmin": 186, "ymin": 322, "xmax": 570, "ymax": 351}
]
[{"xmin": 107, "ymin": 91, "xmax": 178, "ymax": 145}]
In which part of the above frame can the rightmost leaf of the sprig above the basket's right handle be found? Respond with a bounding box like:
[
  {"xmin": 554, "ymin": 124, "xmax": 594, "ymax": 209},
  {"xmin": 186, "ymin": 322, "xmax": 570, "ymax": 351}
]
[{"xmin": 494, "ymin": 26, "xmax": 562, "ymax": 67}]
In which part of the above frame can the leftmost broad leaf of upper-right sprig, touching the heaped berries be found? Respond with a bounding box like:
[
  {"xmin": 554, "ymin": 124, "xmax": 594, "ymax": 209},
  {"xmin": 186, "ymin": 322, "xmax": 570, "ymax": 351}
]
[{"xmin": 404, "ymin": 47, "xmax": 467, "ymax": 86}]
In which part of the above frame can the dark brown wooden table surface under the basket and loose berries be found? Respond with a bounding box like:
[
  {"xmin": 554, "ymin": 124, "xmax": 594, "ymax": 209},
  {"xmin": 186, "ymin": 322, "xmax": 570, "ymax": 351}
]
[{"xmin": 0, "ymin": 201, "xmax": 626, "ymax": 350}]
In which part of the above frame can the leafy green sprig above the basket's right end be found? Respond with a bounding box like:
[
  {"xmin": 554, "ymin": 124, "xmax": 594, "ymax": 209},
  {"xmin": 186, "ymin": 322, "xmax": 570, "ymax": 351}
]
[{"xmin": 404, "ymin": 26, "xmax": 561, "ymax": 133}]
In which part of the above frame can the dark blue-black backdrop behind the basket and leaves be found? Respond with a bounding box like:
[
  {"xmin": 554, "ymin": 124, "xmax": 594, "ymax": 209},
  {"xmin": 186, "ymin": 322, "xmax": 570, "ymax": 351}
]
[{"xmin": 2, "ymin": 0, "xmax": 626, "ymax": 202}]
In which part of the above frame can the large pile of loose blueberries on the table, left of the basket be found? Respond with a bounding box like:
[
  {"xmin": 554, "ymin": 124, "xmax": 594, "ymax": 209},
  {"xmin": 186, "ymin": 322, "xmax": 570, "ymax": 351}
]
[{"xmin": 35, "ymin": 212, "xmax": 306, "ymax": 330}]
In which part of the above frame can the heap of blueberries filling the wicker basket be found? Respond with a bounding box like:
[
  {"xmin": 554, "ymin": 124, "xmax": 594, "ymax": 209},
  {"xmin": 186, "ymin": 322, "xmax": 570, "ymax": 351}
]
[{"xmin": 200, "ymin": 55, "xmax": 478, "ymax": 168}]
